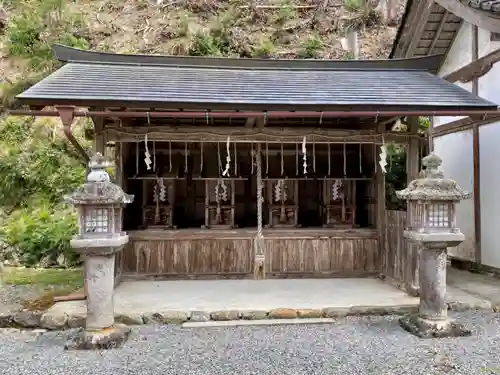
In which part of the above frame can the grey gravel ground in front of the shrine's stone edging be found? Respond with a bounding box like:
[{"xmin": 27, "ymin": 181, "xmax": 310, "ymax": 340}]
[{"xmin": 0, "ymin": 312, "xmax": 500, "ymax": 375}]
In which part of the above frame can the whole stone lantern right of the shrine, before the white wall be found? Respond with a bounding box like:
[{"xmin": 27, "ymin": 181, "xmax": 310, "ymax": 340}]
[{"xmin": 396, "ymin": 154, "xmax": 471, "ymax": 337}]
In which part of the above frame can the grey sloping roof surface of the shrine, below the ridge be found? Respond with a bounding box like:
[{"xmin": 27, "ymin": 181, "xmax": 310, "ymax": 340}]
[{"xmin": 14, "ymin": 45, "xmax": 497, "ymax": 110}]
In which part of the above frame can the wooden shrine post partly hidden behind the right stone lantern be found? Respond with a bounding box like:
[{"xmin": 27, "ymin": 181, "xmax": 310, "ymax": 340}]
[{"xmin": 403, "ymin": 117, "xmax": 420, "ymax": 295}]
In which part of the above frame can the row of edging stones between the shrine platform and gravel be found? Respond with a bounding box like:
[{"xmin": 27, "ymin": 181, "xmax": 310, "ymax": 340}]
[{"xmin": 0, "ymin": 301, "xmax": 492, "ymax": 330}]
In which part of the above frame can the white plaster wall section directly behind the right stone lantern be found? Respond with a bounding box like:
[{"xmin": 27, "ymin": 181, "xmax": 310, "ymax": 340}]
[{"xmin": 434, "ymin": 132, "xmax": 472, "ymax": 261}]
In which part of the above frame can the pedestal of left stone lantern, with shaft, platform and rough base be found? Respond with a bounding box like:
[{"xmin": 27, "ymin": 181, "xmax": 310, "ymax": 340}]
[{"xmin": 66, "ymin": 239, "xmax": 130, "ymax": 349}]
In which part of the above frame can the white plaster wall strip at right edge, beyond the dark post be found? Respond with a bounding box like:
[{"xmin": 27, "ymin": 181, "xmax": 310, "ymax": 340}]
[{"xmin": 479, "ymin": 122, "xmax": 500, "ymax": 268}]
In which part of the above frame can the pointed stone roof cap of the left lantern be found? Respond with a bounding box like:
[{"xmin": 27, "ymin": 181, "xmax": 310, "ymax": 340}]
[{"xmin": 64, "ymin": 153, "xmax": 134, "ymax": 205}]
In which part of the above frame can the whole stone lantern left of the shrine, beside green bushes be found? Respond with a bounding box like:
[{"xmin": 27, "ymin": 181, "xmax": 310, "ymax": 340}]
[{"xmin": 65, "ymin": 153, "xmax": 134, "ymax": 349}]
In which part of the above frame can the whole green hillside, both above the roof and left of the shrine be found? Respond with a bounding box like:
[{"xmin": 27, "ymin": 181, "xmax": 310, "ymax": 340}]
[{"xmin": 0, "ymin": 0, "xmax": 404, "ymax": 265}]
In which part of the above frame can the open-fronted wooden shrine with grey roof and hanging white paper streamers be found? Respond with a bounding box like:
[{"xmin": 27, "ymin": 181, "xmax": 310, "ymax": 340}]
[{"xmin": 11, "ymin": 45, "xmax": 496, "ymax": 279}]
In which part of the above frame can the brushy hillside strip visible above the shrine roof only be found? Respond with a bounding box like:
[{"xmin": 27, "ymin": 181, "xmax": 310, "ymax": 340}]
[{"xmin": 0, "ymin": 0, "xmax": 404, "ymax": 104}]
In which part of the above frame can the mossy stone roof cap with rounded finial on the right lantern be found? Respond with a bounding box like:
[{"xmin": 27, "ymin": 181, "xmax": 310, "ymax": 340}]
[{"xmin": 396, "ymin": 154, "xmax": 472, "ymax": 201}]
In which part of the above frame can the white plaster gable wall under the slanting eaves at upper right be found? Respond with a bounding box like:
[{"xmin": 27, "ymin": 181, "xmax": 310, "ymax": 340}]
[{"xmin": 434, "ymin": 22, "xmax": 472, "ymax": 126}]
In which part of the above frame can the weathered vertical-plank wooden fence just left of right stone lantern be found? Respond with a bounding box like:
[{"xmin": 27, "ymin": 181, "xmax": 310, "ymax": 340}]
[{"xmin": 382, "ymin": 210, "xmax": 418, "ymax": 291}]
